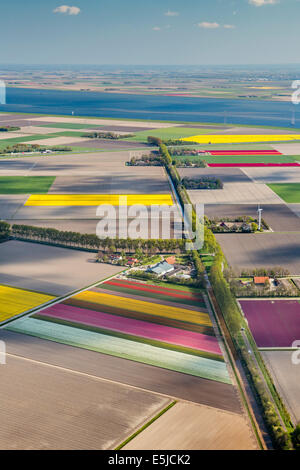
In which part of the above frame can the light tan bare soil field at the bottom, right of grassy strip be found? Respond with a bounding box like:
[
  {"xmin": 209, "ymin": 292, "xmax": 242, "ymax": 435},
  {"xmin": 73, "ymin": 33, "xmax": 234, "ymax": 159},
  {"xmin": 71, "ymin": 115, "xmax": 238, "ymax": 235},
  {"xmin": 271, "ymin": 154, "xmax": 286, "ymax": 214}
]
[{"xmin": 124, "ymin": 403, "xmax": 258, "ymax": 451}]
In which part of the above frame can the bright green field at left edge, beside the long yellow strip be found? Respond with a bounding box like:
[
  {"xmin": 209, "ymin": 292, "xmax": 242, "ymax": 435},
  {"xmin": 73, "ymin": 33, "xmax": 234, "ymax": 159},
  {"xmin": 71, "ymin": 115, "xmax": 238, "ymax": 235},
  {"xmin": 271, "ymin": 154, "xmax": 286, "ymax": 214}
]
[{"xmin": 0, "ymin": 176, "xmax": 55, "ymax": 194}]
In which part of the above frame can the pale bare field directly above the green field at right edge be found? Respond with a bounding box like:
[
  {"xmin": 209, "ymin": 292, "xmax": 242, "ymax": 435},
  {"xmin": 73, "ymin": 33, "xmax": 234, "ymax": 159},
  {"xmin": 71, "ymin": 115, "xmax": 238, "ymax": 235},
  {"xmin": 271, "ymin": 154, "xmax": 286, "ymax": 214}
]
[{"xmin": 243, "ymin": 167, "xmax": 300, "ymax": 183}]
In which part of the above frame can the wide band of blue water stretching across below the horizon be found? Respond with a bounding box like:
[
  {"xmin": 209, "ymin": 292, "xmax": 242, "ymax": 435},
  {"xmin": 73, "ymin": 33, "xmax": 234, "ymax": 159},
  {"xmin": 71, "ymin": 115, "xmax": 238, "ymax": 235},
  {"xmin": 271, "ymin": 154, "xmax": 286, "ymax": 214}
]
[{"xmin": 0, "ymin": 88, "xmax": 300, "ymax": 128}]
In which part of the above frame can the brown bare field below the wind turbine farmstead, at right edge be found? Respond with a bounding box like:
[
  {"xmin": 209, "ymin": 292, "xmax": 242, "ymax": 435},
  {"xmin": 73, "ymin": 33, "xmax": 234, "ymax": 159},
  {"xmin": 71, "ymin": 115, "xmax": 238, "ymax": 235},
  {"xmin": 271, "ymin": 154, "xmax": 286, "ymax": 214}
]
[{"xmin": 216, "ymin": 232, "xmax": 300, "ymax": 275}]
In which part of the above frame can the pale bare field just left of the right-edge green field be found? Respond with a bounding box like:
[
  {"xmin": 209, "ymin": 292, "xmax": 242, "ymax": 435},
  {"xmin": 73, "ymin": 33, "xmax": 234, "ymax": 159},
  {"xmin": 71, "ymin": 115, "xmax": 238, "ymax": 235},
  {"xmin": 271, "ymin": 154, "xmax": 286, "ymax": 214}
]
[{"xmin": 188, "ymin": 183, "xmax": 282, "ymax": 204}]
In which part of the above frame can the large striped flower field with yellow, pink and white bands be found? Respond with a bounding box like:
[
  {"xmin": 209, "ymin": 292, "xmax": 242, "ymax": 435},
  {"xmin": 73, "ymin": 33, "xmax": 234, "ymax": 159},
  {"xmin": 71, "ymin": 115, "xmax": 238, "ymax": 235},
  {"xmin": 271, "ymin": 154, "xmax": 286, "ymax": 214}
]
[{"xmin": 8, "ymin": 283, "xmax": 231, "ymax": 384}]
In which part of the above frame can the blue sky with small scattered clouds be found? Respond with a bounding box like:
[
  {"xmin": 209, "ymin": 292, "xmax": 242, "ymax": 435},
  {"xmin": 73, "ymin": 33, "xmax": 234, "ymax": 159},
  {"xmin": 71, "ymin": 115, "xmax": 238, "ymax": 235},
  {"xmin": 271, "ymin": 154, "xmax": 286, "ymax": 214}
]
[{"xmin": 0, "ymin": 0, "xmax": 300, "ymax": 65}]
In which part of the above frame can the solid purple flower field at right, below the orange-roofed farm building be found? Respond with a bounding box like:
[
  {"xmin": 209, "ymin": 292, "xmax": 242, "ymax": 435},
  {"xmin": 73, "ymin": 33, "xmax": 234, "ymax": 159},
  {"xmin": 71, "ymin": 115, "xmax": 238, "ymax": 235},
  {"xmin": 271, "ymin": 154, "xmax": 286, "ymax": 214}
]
[{"xmin": 240, "ymin": 299, "xmax": 300, "ymax": 348}]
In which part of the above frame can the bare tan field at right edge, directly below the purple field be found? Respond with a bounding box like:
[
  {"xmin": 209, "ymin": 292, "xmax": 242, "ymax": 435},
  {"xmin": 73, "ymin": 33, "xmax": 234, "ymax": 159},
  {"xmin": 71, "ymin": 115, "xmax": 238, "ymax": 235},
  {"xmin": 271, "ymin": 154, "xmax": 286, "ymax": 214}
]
[{"xmin": 261, "ymin": 351, "xmax": 300, "ymax": 424}]
